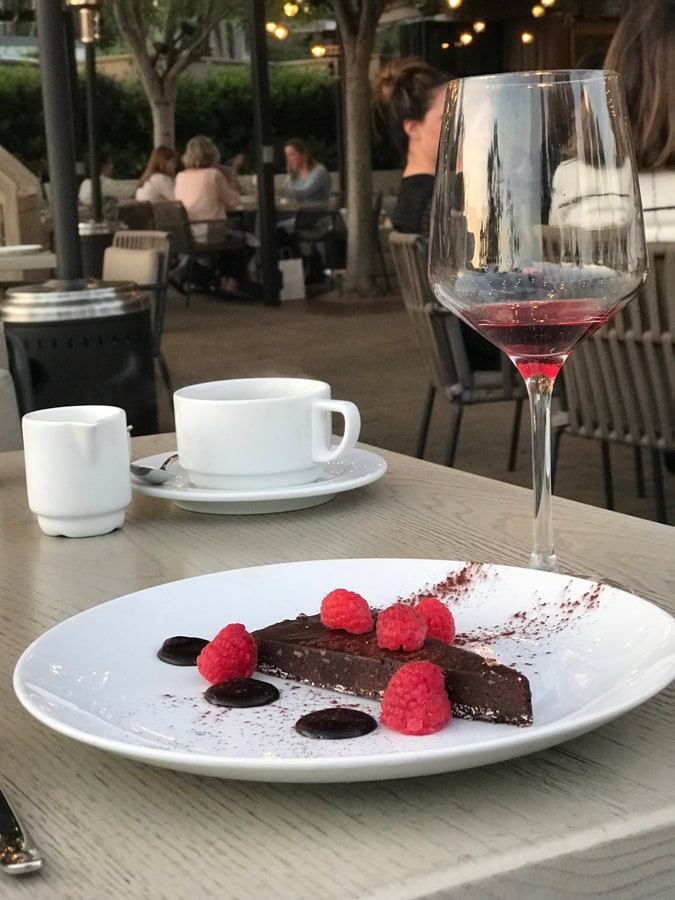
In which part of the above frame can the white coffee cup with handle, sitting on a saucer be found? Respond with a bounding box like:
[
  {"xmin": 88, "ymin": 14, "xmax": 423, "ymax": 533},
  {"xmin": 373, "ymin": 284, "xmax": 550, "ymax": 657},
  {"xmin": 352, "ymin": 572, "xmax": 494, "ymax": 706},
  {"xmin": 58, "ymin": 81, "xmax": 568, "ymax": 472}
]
[{"xmin": 174, "ymin": 378, "xmax": 361, "ymax": 490}]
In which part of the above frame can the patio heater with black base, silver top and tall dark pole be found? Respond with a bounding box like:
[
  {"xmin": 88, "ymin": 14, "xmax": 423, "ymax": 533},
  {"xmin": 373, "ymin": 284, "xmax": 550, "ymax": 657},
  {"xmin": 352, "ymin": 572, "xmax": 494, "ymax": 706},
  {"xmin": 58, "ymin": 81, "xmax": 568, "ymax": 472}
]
[{"xmin": 0, "ymin": 0, "xmax": 157, "ymax": 434}]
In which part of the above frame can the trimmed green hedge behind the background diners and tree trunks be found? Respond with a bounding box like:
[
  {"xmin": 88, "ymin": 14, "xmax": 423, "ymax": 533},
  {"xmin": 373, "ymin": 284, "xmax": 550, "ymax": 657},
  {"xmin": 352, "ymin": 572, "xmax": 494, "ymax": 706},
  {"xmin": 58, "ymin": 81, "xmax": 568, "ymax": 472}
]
[{"xmin": 0, "ymin": 65, "xmax": 397, "ymax": 180}]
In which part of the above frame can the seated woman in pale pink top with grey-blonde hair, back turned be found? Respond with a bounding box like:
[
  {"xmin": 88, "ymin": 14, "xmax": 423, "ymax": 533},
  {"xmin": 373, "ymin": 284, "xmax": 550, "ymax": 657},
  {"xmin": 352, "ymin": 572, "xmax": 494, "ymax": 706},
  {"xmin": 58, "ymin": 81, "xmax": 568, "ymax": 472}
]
[{"xmin": 171, "ymin": 134, "xmax": 250, "ymax": 294}]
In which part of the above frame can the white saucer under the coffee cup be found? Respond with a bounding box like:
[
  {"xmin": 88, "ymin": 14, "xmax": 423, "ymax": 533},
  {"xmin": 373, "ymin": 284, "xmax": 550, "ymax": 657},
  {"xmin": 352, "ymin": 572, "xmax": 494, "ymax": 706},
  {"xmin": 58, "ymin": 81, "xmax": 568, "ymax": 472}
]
[{"xmin": 131, "ymin": 450, "xmax": 387, "ymax": 515}]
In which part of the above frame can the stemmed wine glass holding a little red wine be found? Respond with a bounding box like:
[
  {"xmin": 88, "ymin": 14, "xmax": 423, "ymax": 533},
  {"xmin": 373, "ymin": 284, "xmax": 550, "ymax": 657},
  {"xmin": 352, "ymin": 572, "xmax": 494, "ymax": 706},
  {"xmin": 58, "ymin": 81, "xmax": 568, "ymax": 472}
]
[{"xmin": 429, "ymin": 70, "xmax": 647, "ymax": 571}]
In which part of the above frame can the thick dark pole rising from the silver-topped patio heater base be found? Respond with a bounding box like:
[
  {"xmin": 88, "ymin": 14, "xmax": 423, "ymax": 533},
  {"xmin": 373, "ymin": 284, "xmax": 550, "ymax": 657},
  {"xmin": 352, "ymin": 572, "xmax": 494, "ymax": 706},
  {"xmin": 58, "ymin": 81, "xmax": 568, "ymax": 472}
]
[{"xmin": 36, "ymin": 0, "xmax": 83, "ymax": 282}]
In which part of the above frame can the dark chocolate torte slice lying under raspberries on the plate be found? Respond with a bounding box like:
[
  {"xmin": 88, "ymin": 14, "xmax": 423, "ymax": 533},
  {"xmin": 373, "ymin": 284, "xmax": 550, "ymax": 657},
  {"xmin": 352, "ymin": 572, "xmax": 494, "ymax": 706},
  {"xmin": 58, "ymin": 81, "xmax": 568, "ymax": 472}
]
[{"xmin": 253, "ymin": 615, "xmax": 532, "ymax": 725}]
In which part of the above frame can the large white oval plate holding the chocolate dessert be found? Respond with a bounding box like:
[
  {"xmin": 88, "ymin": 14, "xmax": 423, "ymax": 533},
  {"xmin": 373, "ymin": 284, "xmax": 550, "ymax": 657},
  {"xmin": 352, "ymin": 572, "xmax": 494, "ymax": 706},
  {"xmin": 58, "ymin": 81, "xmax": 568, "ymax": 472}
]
[{"xmin": 14, "ymin": 559, "xmax": 675, "ymax": 782}]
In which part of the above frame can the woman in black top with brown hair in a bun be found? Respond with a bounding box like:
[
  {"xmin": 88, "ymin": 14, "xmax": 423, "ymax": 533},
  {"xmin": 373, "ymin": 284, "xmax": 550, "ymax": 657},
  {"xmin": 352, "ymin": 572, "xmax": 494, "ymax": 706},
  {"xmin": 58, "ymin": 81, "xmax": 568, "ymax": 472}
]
[{"xmin": 375, "ymin": 59, "xmax": 501, "ymax": 369}]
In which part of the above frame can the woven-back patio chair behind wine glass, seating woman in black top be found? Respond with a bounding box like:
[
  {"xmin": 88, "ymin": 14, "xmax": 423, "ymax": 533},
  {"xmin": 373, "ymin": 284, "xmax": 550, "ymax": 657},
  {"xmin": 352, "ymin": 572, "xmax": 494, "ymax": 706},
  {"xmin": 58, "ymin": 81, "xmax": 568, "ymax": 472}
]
[{"xmin": 389, "ymin": 231, "xmax": 526, "ymax": 471}]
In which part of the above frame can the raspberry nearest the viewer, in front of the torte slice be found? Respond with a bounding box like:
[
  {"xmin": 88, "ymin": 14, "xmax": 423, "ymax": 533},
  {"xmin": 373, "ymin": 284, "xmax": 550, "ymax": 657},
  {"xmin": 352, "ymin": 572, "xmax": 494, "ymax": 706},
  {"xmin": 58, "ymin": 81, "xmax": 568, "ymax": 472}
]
[{"xmin": 380, "ymin": 662, "xmax": 452, "ymax": 734}]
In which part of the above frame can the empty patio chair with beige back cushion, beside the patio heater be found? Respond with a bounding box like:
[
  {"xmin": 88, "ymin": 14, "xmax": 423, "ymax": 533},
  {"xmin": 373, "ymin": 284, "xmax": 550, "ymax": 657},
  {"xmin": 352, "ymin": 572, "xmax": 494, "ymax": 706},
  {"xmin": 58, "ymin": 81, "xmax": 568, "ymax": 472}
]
[{"xmin": 103, "ymin": 229, "xmax": 173, "ymax": 396}]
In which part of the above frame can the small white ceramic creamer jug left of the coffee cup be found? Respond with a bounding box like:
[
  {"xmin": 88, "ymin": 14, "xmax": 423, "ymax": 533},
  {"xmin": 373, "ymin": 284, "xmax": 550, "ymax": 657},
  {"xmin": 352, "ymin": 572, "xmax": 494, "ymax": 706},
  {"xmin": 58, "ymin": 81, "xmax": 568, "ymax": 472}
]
[{"xmin": 22, "ymin": 405, "xmax": 131, "ymax": 537}]
